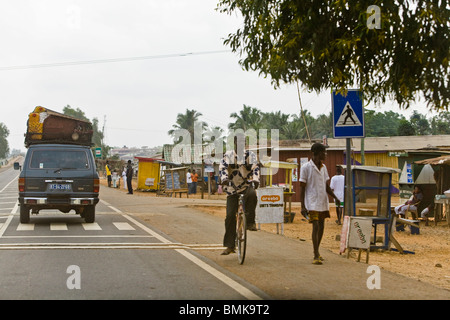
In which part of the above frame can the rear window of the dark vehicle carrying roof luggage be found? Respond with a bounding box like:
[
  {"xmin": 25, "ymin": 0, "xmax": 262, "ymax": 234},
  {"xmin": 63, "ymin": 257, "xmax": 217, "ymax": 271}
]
[{"xmin": 30, "ymin": 150, "xmax": 89, "ymax": 170}]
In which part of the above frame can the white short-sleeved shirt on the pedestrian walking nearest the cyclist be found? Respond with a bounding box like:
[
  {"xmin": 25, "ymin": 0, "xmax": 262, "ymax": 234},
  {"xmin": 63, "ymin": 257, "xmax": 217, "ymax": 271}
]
[{"xmin": 300, "ymin": 160, "xmax": 330, "ymax": 211}]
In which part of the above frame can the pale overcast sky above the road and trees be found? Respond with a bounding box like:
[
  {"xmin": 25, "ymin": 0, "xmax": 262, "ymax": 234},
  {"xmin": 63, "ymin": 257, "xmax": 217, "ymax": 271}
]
[{"xmin": 0, "ymin": 0, "xmax": 431, "ymax": 150}]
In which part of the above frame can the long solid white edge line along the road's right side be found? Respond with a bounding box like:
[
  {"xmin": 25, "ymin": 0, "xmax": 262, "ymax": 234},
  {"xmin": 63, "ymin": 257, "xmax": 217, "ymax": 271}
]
[{"xmin": 100, "ymin": 200, "xmax": 262, "ymax": 300}]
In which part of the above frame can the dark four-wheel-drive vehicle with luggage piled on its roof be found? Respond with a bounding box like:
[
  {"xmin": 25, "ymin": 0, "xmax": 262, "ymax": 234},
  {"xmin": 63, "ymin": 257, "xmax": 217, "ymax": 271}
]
[{"xmin": 14, "ymin": 107, "xmax": 100, "ymax": 223}]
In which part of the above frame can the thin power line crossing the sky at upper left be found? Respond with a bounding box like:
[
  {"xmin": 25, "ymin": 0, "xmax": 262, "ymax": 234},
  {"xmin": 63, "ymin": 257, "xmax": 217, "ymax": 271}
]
[{"xmin": 0, "ymin": 50, "xmax": 231, "ymax": 71}]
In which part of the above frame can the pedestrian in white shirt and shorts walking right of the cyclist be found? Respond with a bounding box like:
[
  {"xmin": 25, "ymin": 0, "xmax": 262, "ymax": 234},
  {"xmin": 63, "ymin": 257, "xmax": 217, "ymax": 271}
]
[{"xmin": 300, "ymin": 143, "xmax": 339, "ymax": 264}]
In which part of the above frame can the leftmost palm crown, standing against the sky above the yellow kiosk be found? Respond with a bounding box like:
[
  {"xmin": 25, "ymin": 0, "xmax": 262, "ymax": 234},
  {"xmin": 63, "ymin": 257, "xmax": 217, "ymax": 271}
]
[{"xmin": 168, "ymin": 109, "xmax": 208, "ymax": 145}]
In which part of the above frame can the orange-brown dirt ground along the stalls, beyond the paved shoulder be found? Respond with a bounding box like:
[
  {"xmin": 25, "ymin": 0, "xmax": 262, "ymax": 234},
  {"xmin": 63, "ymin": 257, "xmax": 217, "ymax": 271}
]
[{"xmin": 102, "ymin": 179, "xmax": 450, "ymax": 290}]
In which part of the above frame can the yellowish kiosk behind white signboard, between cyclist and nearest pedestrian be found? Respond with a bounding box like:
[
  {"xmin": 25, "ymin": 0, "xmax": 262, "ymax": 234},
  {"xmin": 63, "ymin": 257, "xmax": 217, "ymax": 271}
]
[{"xmin": 262, "ymin": 160, "xmax": 298, "ymax": 222}]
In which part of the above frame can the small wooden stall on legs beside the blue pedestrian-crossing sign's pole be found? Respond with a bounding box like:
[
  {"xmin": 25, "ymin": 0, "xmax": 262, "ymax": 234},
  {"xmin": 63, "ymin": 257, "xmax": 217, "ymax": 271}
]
[{"xmin": 342, "ymin": 165, "xmax": 400, "ymax": 250}]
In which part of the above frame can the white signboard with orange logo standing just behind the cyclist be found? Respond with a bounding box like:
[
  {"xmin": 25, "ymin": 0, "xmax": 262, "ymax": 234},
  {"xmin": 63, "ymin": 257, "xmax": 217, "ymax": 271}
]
[{"xmin": 256, "ymin": 187, "xmax": 284, "ymax": 223}]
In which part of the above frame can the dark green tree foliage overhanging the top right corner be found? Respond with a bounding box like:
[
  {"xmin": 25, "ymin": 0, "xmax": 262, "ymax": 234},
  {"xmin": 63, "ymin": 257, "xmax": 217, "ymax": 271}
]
[{"xmin": 218, "ymin": 0, "xmax": 450, "ymax": 111}]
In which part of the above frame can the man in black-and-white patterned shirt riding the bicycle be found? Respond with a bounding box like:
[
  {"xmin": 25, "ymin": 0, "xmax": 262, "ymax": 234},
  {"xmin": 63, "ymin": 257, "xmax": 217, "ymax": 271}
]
[{"xmin": 219, "ymin": 134, "xmax": 260, "ymax": 255}]
